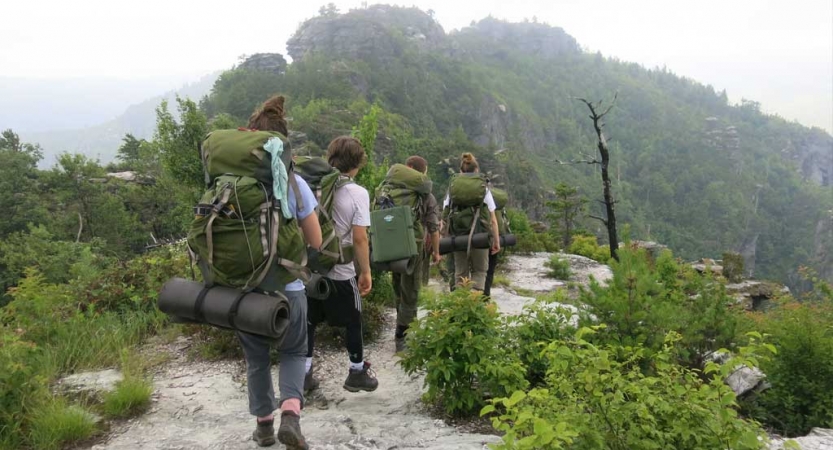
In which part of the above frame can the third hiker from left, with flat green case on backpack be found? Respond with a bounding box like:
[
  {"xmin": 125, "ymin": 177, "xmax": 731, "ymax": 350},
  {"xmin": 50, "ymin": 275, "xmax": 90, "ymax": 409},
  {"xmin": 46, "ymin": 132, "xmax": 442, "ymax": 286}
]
[{"xmin": 375, "ymin": 155, "xmax": 441, "ymax": 353}]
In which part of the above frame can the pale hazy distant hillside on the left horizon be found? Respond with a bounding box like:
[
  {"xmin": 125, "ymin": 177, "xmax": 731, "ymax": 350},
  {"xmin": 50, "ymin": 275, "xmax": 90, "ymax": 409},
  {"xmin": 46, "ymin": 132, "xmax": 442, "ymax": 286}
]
[{"xmin": 19, "ymin": 72, "xmax": 219, "ymax": 167}]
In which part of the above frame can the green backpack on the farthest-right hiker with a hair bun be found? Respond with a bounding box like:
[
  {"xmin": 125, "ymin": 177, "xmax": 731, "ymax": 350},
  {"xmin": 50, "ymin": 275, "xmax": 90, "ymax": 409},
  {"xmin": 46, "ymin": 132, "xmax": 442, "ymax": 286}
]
[{"xmin": 443, "ymin": 173, "xmax": 494, "ymax": 236}]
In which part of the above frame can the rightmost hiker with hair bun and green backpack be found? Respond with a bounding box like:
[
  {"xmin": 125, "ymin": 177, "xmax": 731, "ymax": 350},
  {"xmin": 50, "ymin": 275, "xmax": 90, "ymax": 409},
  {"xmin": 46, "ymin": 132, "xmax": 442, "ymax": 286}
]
[{"xmin": 443, "ymin": 153, "xmax": 500, "ymax": 292}]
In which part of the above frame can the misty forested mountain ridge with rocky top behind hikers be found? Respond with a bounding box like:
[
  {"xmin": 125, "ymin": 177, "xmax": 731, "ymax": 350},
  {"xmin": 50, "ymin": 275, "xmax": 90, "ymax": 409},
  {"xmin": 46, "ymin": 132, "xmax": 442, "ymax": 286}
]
[{"xmin": 201, "ymin": 6, "xmax": 833, "ymax": 282}]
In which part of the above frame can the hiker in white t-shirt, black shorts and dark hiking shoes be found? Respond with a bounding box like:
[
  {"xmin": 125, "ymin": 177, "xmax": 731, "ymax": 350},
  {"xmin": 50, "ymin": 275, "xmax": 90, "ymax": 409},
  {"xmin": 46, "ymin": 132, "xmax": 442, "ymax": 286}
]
[{"xmin": 304, "ymin": 136, "xmax": 379, "ymax": 392}]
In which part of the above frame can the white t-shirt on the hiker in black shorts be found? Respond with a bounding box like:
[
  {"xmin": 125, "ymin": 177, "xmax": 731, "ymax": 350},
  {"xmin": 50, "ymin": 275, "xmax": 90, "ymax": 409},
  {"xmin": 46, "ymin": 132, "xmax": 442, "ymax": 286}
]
[{"xmin": 327, "ymin": 183, "xmax": 370, "ymax": 281}]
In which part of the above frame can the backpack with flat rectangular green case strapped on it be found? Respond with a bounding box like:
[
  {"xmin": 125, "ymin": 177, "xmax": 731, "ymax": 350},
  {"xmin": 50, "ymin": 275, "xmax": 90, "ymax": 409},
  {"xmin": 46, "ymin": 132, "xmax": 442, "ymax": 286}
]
[{"xmin": 370, "ymin": 164, "xmax": 432, "ymax": 262}]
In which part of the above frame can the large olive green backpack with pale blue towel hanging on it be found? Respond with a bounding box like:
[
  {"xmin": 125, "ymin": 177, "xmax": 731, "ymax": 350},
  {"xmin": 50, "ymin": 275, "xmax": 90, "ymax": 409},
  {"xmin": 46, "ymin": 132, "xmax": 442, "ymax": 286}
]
[{"xmin": 188, "ymin": 129, "xmax": 308, "ymax": 291}]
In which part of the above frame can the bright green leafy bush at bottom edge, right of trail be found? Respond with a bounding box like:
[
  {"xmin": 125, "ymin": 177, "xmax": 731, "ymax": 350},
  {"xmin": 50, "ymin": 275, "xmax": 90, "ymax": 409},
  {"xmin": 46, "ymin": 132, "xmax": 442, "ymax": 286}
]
[{"xmin": 481, "ymin": 328, "xmax": 768, "ymax": 450}]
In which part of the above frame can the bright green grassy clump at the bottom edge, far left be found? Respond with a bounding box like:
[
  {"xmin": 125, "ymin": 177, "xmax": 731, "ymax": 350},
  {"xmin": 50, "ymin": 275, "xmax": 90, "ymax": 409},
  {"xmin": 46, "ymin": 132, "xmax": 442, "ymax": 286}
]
[{"xmin": 29, "ymin": 400, "xmax": 96, "ymax": 450}]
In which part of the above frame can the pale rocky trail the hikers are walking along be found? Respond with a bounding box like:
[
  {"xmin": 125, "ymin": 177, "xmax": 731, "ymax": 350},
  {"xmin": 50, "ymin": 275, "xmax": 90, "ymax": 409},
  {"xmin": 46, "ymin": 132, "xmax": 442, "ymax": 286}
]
[{"xmin": 92, "ymin": 254, "xmax": 592, "ymax": 450}]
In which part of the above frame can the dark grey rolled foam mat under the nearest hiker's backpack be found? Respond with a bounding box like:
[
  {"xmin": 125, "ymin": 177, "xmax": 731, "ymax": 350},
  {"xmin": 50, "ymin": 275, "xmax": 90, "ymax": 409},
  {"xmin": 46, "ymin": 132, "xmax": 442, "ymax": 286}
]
[{"xmin": 158, "ymin": 278, "xmax": 289, "ymax": 339}]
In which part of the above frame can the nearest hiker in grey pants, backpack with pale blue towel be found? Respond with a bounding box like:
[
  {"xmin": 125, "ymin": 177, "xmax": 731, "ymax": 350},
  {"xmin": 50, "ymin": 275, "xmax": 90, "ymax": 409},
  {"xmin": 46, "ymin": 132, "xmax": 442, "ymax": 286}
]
[{"xmin": 188, "ymin": 96, "xmax": 322, "ymax": 450}]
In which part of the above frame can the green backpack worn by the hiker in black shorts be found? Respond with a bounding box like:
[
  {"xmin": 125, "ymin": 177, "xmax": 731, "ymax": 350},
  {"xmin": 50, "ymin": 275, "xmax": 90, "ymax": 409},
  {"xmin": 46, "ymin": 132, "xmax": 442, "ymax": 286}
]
[{"xmin": 295, "ymin": 156, "xmax": 353, "ymax": 275}]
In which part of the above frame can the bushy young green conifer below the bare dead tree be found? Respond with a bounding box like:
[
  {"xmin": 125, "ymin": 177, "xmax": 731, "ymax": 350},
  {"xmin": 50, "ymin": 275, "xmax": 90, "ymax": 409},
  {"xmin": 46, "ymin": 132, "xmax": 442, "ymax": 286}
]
[{"xmin": 576, "ymin": 246, "xmax": 738, "ymax": 369}]
